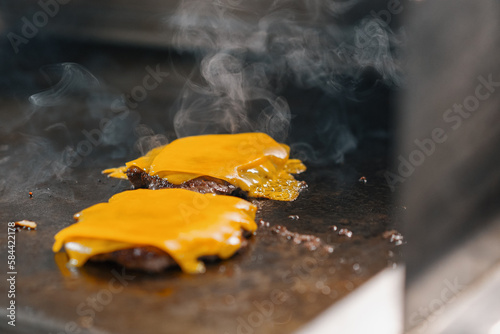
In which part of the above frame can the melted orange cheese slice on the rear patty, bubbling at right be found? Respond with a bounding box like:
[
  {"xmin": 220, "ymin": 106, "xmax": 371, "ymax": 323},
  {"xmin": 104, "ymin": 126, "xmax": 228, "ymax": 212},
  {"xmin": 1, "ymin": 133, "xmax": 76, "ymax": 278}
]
[{"xmin": 103, "ymin": 133, "xmax": 306, "ymax": 201}]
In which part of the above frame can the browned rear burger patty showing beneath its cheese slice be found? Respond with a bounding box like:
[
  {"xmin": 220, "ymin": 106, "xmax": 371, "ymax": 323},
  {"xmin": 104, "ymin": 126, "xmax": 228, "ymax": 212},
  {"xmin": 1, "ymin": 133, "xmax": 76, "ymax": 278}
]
[{"xmin": 126, "ymin": 167, "xmax": 238, "ymax": 195}]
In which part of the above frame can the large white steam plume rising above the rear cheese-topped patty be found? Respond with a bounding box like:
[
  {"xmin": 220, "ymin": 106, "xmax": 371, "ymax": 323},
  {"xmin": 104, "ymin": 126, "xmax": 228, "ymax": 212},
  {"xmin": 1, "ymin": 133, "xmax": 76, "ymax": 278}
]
[{"xmin": 170, "ymin": 0, "xmax": 401, "ymax": 161}]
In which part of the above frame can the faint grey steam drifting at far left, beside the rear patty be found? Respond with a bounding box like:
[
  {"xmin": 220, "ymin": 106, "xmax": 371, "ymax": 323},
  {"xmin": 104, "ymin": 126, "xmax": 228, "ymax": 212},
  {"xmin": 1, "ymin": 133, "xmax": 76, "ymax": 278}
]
[{"xmin": 0, "ymin": 63, "xmax": 146, "ymax": 202}]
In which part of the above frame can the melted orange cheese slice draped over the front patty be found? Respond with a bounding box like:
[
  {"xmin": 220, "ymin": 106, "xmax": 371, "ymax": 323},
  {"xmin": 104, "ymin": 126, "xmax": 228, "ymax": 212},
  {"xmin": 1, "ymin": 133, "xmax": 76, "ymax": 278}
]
[{"xmin": 53, "ymin": 189, "xmax": 257, "ymax": 273}]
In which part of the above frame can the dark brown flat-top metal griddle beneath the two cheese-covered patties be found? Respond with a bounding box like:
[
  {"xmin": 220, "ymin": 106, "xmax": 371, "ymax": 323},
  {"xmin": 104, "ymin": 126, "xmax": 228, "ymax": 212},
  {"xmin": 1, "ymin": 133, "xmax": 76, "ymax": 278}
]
[{"xmin": 0, "ymin": 41, "xmax": 404, "ymax": 334}]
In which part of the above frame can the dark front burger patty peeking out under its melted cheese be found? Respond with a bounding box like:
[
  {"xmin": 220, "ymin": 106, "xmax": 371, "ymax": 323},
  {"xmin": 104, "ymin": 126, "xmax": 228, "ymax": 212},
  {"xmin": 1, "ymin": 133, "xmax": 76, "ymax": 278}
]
[{"xmin": 89, "ymin": 231, "xmax": 251, "ymax": 273}]
